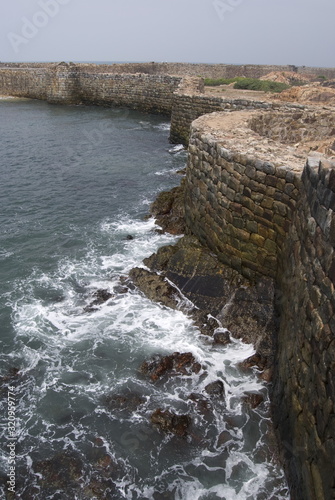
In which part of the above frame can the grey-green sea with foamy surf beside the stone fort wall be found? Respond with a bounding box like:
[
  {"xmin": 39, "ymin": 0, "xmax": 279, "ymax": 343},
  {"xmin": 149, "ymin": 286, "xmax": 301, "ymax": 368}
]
[{"xmin": 0, "ymin": 99, "xmax": 289, "ymax": 500}]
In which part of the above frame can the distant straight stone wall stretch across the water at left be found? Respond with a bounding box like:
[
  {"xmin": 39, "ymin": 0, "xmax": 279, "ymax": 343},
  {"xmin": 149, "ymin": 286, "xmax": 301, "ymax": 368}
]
[{"xmin": 0, "ymin": 63, "xmax": 181, "ymax": 116}]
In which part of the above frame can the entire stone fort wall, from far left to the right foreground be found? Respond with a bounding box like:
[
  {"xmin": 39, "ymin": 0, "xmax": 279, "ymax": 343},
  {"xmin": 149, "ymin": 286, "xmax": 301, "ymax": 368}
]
[{"xmin": 0, "ymin": 64, "xmax": 335, "ymax": 500}]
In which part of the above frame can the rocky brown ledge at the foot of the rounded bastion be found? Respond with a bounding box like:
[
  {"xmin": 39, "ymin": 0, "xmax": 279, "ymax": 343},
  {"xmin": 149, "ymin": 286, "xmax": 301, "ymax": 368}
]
[{"xmin": 126, "ymin": 180, "xmax": 278, "ymax": 374}]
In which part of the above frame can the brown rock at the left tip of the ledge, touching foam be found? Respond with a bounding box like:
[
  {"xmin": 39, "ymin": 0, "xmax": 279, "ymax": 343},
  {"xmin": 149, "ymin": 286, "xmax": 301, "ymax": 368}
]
[{"xmin": 129, "ymin": 267, "xmax": 178, "ymax": 309}]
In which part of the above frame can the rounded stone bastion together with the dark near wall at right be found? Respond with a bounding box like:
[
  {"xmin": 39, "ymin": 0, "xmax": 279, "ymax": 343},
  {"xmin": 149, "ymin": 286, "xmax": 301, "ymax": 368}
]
[{"xmin": 185, "ymin": 113, "xmax": 335, "ymax": 500}]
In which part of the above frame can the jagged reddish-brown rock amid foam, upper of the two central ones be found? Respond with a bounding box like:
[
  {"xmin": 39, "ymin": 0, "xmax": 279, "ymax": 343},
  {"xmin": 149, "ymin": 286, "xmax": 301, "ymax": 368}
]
[{"xmin": 140, "ymin": 352, "xmax": 201, "ymax": 382}]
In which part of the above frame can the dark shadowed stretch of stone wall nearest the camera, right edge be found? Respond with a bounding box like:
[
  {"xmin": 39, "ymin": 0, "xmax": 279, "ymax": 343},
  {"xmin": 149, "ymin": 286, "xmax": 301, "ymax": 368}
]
[{"xmin": 273, "ymin": 159, "xmax": 335, "ymax": 500}]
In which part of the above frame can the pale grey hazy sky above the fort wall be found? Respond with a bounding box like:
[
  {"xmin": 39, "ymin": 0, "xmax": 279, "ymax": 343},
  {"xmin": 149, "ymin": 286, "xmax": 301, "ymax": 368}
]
[{"xmin": 0, "ymin": 0, "xmax": 335, "ymax": 67}]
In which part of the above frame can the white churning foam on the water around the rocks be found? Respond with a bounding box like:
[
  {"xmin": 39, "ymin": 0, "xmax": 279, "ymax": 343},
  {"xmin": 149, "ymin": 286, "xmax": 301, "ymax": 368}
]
[{"xmin": 9, "ymin": 208, "xmax": 285, "ymax": 500}]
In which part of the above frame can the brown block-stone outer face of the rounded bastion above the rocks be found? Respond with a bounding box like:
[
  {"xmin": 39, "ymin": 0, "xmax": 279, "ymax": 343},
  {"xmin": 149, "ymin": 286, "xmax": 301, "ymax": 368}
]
[{"xmin": 185, "ymin": 116, "xmax": 301, "ymax": 279}]
